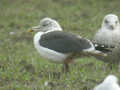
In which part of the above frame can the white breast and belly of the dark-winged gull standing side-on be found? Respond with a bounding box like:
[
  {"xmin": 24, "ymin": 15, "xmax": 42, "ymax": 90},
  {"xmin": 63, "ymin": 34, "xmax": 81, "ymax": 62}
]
[{"xmin": 34, "ymin": 32, "xmax": 68, "ymax": 63}]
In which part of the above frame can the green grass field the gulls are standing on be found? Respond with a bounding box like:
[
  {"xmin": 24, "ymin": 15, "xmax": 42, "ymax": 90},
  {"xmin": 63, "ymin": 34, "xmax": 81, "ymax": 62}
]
[{"xmin": 0, "ymin": 0, "xmax": 120, "ymax": 90}]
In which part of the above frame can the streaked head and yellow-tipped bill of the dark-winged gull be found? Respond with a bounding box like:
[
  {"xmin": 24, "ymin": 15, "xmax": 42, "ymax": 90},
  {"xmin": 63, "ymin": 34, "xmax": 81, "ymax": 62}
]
[{"xmin": 29, "ymin": 17, "xmax": 62, "ymax": 32}]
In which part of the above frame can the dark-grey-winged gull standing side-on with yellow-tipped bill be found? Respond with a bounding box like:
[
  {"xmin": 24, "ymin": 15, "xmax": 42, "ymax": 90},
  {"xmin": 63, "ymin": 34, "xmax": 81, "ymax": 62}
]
[{"xmin": 30, "ymin": 18, "xmax": 104, "ymax": 71}]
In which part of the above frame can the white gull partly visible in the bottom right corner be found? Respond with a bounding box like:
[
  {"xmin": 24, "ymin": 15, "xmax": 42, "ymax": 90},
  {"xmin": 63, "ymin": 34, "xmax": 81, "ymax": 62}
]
[{"xmin": 93, "ymin": 75, "xmax": 120, "ymax": 90}]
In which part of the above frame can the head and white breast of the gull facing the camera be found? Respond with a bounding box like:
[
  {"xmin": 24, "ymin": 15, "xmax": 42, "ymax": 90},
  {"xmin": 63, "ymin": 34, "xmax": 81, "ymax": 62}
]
[{"xmin": 94, "ymin": 14, "xmax": 120, "ymax": 48}]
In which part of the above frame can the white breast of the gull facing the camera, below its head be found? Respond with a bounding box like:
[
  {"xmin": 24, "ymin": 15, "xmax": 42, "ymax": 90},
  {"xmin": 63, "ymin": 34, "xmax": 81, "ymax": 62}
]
[{"xmin": 94, "ymin": 30, "xmax": 120, "ymax": 46}]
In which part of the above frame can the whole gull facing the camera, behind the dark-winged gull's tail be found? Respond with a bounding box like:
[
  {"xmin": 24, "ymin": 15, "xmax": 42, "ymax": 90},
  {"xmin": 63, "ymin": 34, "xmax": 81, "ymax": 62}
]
[{"xmin": 93, "ymin": 14, "xmax": 120, "ymax": 71}]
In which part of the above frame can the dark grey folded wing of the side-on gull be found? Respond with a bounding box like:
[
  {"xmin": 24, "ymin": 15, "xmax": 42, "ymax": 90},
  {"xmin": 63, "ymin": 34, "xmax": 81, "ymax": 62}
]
[{"xmin": 39, "ymin": 31, "xmax": 91, "ymax": 53}]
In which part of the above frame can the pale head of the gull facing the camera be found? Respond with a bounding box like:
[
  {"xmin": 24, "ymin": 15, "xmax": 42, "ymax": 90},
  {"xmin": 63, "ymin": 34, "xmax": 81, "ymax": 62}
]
[{"xmin": 102, "ymin": 14, "xmax": 119, "ymax": 30}]
